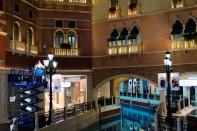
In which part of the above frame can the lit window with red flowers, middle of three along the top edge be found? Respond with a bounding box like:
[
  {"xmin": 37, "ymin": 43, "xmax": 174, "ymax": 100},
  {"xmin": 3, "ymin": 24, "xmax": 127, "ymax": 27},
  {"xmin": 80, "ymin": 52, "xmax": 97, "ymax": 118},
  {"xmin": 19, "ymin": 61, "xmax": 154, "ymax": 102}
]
[{"xmin": 128, "ymin": 0, "xmax": 139, "ymax": 15}]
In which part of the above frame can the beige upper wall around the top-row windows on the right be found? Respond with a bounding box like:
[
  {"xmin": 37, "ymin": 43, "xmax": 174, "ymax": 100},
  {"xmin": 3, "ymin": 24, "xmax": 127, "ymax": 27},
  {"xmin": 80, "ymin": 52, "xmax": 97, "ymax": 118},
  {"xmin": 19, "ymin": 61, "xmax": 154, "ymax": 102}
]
[{"xmin": 92, "ymin": 0, "xmax": 197, "ymax": 22}]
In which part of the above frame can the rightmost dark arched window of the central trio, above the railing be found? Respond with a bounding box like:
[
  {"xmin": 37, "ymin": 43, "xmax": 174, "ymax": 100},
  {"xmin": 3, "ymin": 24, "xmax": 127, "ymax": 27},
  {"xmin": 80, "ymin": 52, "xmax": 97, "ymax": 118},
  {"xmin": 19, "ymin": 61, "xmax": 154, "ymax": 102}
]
[{"xmin": 128, "ymin": 26, "xmax": 140, "ymax": 43}]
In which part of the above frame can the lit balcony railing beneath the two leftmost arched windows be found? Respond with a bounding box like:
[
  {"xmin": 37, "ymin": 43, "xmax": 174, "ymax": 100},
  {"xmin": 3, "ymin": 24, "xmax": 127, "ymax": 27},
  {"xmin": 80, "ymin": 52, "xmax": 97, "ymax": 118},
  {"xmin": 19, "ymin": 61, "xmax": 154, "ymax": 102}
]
[{"xmin": 9, "ymin": 40, "xmax": 38, "ymax": 54}]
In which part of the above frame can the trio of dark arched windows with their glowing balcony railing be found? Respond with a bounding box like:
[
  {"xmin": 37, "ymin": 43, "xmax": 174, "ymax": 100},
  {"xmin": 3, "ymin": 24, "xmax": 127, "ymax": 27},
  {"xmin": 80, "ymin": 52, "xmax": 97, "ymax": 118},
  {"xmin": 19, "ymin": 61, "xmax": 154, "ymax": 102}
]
[{"xmin": 108, "ymin": 26, "xmax": 141, "ymax": 55}]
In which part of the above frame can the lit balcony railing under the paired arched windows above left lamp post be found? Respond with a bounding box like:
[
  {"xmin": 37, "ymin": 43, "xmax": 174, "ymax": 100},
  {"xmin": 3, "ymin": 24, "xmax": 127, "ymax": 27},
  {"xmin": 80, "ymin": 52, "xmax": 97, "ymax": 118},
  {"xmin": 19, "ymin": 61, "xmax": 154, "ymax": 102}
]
[{"xmin": 54, "ymin": 48, "xmax": 79, "ymax": 56}]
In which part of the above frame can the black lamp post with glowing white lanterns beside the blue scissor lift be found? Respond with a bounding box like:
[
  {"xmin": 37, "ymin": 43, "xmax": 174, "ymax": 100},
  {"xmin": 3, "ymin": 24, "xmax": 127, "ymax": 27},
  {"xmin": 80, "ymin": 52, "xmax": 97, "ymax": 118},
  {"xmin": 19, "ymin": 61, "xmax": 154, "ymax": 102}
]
[{"xmin": 43, "ymin": 53, "xmax": 57, "ymax": 124}]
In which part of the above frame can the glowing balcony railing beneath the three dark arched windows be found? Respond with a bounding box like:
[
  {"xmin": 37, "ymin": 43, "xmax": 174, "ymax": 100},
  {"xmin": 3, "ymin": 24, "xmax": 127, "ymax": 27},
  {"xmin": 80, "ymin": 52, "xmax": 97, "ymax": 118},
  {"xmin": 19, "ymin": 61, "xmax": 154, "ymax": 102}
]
[{"xmin": 108, "ymin": 44, "xmax": 141, "ymax": 55}]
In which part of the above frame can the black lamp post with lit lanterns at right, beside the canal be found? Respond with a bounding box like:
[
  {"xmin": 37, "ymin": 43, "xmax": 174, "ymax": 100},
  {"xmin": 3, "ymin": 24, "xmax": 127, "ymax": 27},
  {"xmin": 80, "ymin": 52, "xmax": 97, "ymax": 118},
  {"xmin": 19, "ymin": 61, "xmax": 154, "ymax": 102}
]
[{"xmin": 164, "ymin": 51, "xmax": 172, "ymax": 129}]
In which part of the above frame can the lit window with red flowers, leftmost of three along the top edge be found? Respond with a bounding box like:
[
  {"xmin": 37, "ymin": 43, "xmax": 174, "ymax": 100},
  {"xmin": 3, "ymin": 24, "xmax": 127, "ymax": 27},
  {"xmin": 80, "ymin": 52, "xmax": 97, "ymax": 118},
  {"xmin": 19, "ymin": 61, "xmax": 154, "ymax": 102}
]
[{"xmin": 109, "ymin": 0, "xmax": 119, "ymax": 18}]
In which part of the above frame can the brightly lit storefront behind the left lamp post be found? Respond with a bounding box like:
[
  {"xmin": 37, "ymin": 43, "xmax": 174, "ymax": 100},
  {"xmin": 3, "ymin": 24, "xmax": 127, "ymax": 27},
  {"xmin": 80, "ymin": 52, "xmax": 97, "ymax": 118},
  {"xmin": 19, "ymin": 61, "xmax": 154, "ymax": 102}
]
[{"xmin": 44, "ymin": 74, "xmax": 87, "ymax": 111}]
